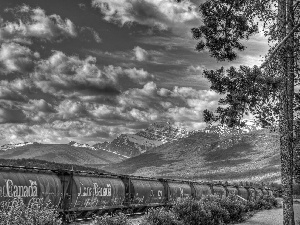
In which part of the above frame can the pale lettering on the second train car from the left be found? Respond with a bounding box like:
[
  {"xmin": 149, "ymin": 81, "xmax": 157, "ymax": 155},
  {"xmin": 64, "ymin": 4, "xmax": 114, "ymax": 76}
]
[{"xmin": 78, "ymin": 183, "xmax": 111, "ymax": 197}]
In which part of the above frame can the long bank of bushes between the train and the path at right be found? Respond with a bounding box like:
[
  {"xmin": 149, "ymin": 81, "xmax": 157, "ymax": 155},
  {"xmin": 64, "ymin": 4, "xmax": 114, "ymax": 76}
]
[{"xmin": 141, "ymin": 195, "xmax": 279, "ymax": 225}]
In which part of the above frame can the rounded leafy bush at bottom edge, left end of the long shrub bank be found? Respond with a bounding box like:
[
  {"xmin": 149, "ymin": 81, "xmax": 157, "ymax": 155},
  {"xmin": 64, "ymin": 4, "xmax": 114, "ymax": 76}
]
[{"xmin": 140, "ymin": 208, "xmax": 184, "ymax": 225}]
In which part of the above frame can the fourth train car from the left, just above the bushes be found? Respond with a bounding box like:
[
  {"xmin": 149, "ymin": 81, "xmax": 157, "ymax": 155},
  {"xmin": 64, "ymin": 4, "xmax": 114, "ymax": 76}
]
[{"xmin": 161, "ymin": 179, "xmax": 192, "ymax": 205}]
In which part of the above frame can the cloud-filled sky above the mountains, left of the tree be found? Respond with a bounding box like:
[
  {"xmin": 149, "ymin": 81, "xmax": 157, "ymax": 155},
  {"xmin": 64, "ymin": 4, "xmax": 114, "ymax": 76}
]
[{"xmin": 0, "ymin": 0, "xmax": 268, "ymax": 145}]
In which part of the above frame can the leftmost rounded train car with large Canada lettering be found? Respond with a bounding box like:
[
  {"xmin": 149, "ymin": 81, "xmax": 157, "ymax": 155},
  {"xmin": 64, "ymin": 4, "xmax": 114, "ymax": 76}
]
[{"xmin": 0, "ymin": 166, "xmax": 62, "ymax": 210}]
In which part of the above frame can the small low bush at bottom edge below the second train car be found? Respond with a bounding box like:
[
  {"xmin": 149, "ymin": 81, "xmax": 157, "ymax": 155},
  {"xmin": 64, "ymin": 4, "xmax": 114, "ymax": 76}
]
[{"xmin": 92, "ymin": 213, "xmax": 131, "ymax": 225}]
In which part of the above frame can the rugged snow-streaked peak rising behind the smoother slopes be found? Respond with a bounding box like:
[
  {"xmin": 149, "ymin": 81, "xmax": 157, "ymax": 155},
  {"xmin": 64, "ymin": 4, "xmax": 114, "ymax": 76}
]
[{"xmin": 93, "ymin": 123, "xmax": 189, "ymax": 157}]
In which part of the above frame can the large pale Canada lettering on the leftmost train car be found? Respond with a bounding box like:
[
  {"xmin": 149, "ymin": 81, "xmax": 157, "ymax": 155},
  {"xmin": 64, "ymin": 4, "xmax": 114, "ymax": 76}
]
[{"xmin": 0, "ymin": 179, "xmax": 38, "ymax": 198}]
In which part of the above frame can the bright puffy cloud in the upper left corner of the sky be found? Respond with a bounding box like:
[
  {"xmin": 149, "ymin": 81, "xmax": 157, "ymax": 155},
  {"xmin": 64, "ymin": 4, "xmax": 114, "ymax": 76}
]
[{"xmin": 0, "ymin": 5, "xmax": 77, "ymax": 44}]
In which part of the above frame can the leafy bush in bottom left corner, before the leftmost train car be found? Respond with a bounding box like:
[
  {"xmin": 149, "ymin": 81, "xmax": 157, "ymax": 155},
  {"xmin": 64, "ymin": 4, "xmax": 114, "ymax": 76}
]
[{"xmin": 0, "ymin": 198, "xmax": 62, "ymax": 225}]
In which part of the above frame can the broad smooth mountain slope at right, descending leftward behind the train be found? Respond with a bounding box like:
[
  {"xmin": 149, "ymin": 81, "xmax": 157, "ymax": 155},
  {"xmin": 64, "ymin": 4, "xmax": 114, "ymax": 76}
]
[{"xmin": 104, "ymin": 129, "xmax": 280, "ymax": 181}]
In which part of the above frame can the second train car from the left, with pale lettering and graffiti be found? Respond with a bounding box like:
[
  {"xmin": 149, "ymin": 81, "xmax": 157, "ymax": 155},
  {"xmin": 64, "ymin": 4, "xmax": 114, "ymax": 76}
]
[{"xmin": 58, "ymin": 171, "xmax": 125, "ymax": 221}]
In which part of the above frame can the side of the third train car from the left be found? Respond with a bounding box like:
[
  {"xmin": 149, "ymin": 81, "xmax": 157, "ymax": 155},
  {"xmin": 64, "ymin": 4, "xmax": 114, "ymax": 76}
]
[{"xmin": 131, "ymin": 178, "xmax": 165, "ymax": 206}]
